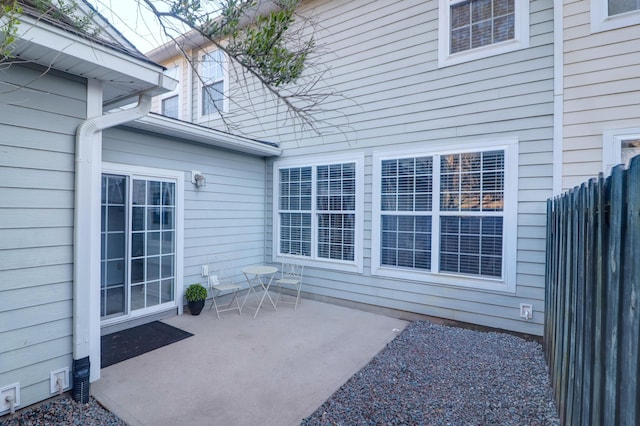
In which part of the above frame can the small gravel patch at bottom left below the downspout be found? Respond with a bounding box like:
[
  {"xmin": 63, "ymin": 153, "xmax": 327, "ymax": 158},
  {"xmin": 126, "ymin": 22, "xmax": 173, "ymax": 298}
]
[{"xmin": 0, "ymin": 396, "xmax": 126, "ymax": 426}]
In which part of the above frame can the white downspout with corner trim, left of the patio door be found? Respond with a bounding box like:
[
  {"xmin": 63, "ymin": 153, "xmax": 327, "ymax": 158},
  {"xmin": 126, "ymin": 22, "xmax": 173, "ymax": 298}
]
[{"xmin": 73, "ymin": 80, "xmax": 151, "ymax": 382}]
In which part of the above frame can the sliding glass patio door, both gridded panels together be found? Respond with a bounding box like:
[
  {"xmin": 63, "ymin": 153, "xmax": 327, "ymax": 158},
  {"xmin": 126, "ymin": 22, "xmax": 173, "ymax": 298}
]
[{"xmin": 100, "ymin": 174, "xmax": 176, "ymax": 319}]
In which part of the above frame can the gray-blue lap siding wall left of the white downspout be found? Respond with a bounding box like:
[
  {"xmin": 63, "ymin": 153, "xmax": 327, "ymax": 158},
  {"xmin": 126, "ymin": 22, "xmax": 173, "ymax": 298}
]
[{"xmin": 0, "ymin": 64, "xmax": 86, "ymax": 412}]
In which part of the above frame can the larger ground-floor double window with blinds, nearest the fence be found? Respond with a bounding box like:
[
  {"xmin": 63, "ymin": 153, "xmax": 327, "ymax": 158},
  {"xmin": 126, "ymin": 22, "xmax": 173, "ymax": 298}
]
[{"xmin": 373, "ymin": 143, "xmax": 516, "ymax": 290}]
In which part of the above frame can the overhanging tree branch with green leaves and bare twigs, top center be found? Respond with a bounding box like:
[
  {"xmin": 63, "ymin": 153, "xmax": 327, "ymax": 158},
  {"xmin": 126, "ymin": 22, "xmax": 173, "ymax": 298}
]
[{"xmin": 141, "ymin": 0, "xmax": 337, "ymax": 133}]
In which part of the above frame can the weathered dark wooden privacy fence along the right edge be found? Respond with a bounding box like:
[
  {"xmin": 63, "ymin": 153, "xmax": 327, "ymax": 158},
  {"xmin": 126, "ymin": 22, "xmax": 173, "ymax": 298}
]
[{"xmin": 544, "ymin": 156, "xmax": 640, "ymax": 426}]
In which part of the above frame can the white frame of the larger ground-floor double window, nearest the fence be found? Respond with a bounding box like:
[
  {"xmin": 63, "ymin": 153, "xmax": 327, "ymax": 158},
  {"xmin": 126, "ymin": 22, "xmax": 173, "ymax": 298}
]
[{"xmin": 371, "ymin": 138, "xmax": 518, "ymax": 293}]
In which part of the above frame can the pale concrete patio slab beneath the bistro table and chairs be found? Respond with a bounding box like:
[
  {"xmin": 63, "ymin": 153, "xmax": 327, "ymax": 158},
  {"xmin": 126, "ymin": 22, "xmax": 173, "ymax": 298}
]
[{"xmin": 91, "ymin": 298, "xmax": 408, "ymax": 426}]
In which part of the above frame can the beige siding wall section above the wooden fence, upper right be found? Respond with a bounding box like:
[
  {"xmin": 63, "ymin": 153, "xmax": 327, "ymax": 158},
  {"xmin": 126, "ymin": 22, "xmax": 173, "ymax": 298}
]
[{"xmin": 562, "ymin": 1, "xmax": 640, "ymax": 189}]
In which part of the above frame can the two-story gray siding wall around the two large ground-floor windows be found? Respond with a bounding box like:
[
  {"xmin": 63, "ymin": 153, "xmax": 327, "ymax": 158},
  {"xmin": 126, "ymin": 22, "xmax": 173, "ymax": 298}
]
[{"xmin": 156, "ymin": 0, "xmax": 554, "ymax": 334}]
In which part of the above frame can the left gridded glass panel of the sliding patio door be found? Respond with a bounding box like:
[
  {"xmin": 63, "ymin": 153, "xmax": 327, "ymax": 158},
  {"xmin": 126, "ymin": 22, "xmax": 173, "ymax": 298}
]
[{"xmin": 100, "ymin": 175, "xmax": 128, "ymax": 318}]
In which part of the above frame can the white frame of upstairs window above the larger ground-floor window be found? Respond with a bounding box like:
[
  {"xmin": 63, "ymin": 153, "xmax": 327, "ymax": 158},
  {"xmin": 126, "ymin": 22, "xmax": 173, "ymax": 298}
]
[{"xmin": 438, "ymin": 0, "xmax": 529, "ymax": 67}]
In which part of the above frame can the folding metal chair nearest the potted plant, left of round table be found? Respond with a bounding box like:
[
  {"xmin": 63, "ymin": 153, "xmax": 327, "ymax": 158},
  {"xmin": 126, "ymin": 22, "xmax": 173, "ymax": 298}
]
[{"xmin": 208, "ymin": 255, "xmax": 242, "ymax": 319}]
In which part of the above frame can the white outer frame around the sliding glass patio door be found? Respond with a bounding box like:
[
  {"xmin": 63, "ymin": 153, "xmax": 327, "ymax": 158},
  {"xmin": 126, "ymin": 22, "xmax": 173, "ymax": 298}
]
[{"xmin": 100, "ymin": 162, "xmax": 185, "ymax": 327}]
